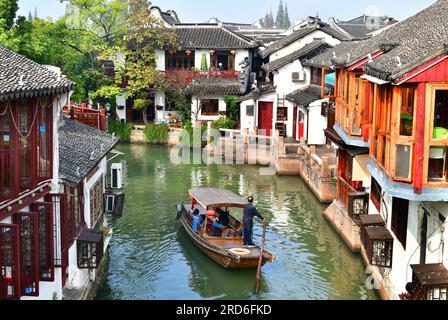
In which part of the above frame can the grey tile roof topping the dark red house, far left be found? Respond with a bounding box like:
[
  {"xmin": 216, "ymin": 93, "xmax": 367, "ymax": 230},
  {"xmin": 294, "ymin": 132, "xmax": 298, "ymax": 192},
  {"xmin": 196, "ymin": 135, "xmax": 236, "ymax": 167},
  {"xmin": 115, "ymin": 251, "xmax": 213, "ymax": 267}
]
[{"xmin": 0, "ymin": 46, "xmax": 74, "ymax": 101}]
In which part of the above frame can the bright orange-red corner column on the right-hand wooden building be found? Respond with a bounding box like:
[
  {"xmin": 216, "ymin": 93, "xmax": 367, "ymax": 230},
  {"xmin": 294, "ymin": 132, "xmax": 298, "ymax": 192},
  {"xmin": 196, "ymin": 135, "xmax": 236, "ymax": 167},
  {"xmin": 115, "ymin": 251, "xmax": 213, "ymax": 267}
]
[{"xmin": 413, "ymin": 83, "xmax": 426, "ymax": 194}]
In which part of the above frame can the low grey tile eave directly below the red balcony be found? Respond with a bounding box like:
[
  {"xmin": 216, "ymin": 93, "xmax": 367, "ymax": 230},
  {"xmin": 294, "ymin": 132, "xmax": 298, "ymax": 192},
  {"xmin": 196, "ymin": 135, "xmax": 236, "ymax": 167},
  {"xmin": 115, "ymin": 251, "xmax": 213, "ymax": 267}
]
[{"xmin": 183, "ymin": 78, "xmax": 246, "ymax": 96}]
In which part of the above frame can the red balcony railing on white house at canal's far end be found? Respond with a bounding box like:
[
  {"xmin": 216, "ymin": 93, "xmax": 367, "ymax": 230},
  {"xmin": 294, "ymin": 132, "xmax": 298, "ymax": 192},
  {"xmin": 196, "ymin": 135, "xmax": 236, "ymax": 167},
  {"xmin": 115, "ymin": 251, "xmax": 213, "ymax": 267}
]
[{"xmin": 165, "ymin": 70, "xmax": 240, "ymax": 89}]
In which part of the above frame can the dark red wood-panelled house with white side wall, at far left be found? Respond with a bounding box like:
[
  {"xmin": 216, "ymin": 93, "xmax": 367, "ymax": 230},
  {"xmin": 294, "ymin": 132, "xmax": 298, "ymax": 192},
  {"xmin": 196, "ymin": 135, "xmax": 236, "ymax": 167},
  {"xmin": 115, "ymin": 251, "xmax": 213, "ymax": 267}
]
[{"xmin": 0, "ymin": 46, "xmax": 74, "ymax": 300}]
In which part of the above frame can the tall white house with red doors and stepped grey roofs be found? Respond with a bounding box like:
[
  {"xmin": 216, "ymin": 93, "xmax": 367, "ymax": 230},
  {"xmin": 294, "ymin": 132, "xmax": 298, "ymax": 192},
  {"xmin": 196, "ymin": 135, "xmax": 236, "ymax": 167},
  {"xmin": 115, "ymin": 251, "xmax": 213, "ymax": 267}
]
[{"xmin": 240, "ymin": 19, "xmax": 347, "ymax": 140}]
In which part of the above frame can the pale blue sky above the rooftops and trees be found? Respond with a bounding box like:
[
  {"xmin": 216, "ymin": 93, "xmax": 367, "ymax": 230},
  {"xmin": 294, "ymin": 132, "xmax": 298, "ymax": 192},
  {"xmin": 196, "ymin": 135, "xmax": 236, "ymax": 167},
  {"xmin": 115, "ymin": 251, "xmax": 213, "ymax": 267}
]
[{"xmin": 18, "ymin": 0, "xmax": 436, "ymax": 23}]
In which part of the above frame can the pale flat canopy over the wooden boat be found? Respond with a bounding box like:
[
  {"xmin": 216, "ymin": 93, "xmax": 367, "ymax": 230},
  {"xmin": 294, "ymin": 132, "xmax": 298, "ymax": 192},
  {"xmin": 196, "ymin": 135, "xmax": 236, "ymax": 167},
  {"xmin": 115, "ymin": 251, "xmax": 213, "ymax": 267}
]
[{"xmin": 190, "ymin": 188, "xmax": 247, "ymax": 208}]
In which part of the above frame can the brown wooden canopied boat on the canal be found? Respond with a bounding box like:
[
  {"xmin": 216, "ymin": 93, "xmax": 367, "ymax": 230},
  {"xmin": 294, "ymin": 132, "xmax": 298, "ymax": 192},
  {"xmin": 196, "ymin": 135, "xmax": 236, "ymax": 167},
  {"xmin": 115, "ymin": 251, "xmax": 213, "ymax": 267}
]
[{"xmin": 177, "ymin": 188, "xmax": 275, "ymax": 269}]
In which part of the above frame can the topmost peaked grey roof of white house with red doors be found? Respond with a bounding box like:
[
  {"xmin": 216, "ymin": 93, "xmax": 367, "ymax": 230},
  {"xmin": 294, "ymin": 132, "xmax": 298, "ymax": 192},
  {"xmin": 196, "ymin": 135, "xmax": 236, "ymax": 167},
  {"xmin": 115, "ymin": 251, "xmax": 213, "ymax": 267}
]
[{"xmin": 260, "ymin": 24, "xmax": 348, "ymax": 59}]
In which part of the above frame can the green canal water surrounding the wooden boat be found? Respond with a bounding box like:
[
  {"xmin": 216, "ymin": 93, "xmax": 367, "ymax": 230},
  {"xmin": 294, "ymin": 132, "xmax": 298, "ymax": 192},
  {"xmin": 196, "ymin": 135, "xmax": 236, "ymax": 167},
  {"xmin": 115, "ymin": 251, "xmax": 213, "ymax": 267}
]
[{"xmin": 96, "ymin": 145, "xmax": 378, "ymax": 300}]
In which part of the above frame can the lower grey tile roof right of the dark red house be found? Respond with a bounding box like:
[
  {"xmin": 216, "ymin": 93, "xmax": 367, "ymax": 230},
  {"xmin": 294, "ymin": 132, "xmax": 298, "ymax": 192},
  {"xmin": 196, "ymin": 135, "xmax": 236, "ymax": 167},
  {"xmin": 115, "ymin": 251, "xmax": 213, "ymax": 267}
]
[{"xmin": 59, "ymin": 119, "xmax": 118, "ymax": 185}]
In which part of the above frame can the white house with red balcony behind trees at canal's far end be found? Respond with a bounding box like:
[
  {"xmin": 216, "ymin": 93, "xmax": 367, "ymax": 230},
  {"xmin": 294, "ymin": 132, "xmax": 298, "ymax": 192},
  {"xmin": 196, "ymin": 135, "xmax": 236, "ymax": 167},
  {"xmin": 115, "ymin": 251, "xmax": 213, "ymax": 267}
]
[{"xmin": 155, "ymin": 23, "xmax": 256, "ymax": 124}]
